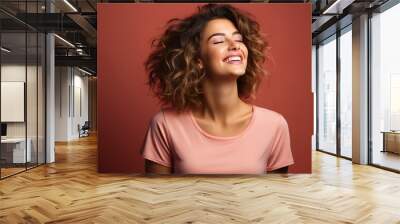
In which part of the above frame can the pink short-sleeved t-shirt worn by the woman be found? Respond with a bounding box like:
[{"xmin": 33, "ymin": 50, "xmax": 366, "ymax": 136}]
[{"xmin": 141, "ymin": 105, "xmax": 294, "ymax": 174}]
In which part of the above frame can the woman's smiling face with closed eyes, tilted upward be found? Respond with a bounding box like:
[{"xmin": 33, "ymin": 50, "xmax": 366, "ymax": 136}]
[{"xmin": 200, "ymin": 19, "xmax": 248, "ymax": 77}]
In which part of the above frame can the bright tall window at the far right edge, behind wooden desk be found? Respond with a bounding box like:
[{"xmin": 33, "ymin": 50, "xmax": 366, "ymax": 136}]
[{"xmin": 370, "ymin": 4, "xmax": 400, "ymax": 170}]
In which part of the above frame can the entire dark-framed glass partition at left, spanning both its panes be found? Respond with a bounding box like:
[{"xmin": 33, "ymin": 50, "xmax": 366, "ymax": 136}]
[{"xmin": 0, "ymin": 1, "xmax": 46, "ymax": 179}]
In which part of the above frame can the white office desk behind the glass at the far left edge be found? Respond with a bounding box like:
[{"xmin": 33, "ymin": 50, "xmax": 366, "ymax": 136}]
[{"xmin": 1, "ymin": 138, "xmax": 32, "ymax": 163}]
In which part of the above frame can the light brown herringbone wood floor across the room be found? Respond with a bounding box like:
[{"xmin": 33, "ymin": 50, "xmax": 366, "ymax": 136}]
[{"xmin": 0, "ymin": 134, "xmax": 400, "ymax": 224}]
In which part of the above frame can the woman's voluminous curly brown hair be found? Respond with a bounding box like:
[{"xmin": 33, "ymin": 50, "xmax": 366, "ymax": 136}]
[{"xmin": 145, "ymin": 4, "xmax": 267, "ymax": 111}]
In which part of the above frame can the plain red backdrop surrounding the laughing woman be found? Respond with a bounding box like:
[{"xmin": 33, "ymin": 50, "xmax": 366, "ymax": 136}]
[{"xmin": 97, "ymin": 3, "xmax": 313, "ymax": 173}]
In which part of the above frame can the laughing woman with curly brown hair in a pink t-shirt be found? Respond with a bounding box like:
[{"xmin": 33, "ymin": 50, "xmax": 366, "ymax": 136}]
[{"xmin": 141, "ymin": 4, "xmax": 294, "ymax": 174}]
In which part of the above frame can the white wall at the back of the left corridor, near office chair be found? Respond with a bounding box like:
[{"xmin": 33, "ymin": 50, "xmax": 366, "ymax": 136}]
[{"xmin": 55, "ymin": 67, "xmax": 89, "ymax": 141}]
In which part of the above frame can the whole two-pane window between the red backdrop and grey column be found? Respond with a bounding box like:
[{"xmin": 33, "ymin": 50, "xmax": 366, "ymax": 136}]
[{"xmin": 316, "ymin": 24, "xmax": 352, "ymax": 158}]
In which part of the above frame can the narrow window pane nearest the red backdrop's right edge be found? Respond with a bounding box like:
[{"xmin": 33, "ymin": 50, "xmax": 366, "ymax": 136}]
[{"xmin": 317, "ymin": 36, "xmax": 337, "ymax": 154}]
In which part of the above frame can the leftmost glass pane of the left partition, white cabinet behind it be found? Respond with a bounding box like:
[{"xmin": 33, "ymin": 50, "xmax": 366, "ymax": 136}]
[{"xmin": 0, "ymin": 32, "xmax": 27, "ymax": 177}]
